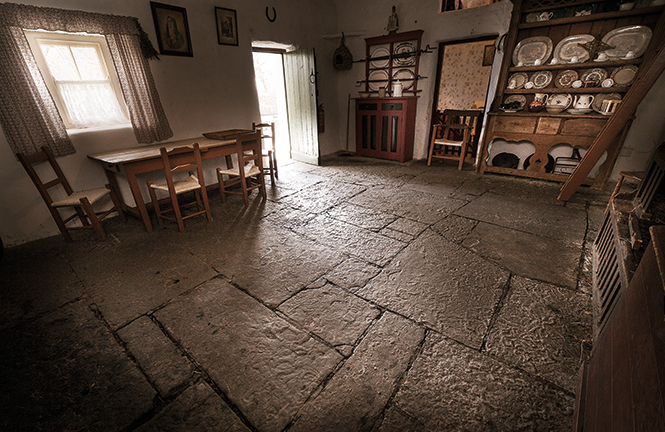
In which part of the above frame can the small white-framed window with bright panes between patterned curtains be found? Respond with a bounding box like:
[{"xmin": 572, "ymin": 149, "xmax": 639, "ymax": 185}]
[{"xmin": 25, "ymin": 31, "xmax": 129, "ymax": 129}]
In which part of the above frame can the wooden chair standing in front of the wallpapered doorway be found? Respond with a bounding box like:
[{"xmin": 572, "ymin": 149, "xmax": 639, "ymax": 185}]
[{"xmin": 427, "ymin": 110, "xmax": 482, "ymax": 170}]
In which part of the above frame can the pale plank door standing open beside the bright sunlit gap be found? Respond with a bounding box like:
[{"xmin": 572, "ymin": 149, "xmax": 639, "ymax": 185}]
[{"xmin": 282, "ymin": 48, "xmax": 320, "ymax": 165}]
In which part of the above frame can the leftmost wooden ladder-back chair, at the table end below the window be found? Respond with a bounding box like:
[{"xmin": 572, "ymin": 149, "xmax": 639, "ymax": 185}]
[{"xmin": 16, "ymin": 147, "xmax": 126, "ymax": 242}]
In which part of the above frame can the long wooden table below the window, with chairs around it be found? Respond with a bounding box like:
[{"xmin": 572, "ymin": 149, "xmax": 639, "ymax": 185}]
[{"xmin": 88, "ymin": 137, "xmax": 252, "ymax": 231}]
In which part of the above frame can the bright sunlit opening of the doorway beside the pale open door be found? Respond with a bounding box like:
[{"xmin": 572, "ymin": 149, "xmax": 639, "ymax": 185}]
[{"xmin": 253, "ymin": 47, "xmax": 291, "ymax": 164}]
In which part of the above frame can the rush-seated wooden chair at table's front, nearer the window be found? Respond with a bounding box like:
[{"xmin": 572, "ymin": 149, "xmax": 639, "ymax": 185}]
[{"xmin": 148, "ymin": 143, "xmax": 212, "ymax": 231}]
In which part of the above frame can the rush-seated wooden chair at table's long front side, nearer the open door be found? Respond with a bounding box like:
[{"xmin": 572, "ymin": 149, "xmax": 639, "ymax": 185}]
[{"xmin": 217, "ymin": 130, "xmax": 266, "ymax": 207}]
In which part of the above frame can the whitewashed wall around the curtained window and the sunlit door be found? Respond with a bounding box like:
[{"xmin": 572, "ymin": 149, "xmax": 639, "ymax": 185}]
[{"xmin": 0, "ymin": 0, "xmax": 339, "ymax": 246}]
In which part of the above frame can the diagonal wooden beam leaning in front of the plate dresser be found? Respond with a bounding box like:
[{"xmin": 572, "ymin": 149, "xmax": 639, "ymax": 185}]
[{"xmin": 558, "ymin": 12, "xmax": 665, "ymax": 201}]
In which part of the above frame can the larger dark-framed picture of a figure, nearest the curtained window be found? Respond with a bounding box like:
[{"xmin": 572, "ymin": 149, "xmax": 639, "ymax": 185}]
[{"xmin": 150, "ymin": 1, "xmax": 194, "ymax": 57}]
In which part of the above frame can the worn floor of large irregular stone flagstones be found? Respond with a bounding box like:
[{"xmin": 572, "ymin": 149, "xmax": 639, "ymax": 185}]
[{"xmin": 0, "ymin": 157, "xmax": 608, "ymax": 432}]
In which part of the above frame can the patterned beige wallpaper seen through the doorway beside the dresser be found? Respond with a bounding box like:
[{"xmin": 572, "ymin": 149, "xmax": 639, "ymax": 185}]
[{"xmin": 437, "ymin": 41, "xmax": 492, "ymax": 110}]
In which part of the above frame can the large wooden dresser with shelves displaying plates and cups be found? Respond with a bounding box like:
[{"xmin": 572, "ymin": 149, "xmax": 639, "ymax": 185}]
[{"xmin": 478, "ymin": 0, "xmax": 664, "ymax": 188}]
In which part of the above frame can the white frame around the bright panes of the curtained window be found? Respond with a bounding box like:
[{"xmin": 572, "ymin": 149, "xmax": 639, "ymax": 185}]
[{"xmin": 23, "ymin": 29, "xmax": 132, "ymax": 130}]
